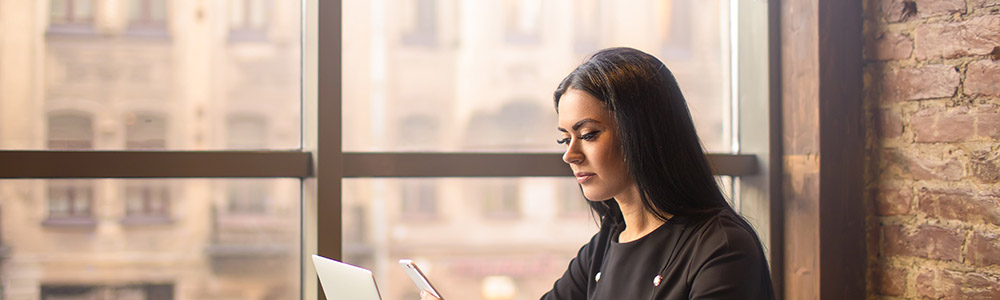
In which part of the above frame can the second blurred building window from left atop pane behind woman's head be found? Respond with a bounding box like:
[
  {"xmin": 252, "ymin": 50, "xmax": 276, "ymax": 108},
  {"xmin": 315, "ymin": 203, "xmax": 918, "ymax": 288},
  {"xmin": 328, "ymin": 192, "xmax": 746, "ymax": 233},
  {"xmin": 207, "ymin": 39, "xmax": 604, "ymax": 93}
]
[{"xmin": 504, "ymin": 0, "xmax": 542, "ymax": 44}]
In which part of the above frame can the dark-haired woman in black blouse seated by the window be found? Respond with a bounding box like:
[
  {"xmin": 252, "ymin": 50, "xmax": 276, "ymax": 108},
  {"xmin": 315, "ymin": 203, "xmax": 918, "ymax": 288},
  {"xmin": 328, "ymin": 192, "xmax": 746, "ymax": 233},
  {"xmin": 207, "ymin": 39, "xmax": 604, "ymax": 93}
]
[{"xmin": 422, "ymin": 48, "xmax": 774, "ymax": 300}]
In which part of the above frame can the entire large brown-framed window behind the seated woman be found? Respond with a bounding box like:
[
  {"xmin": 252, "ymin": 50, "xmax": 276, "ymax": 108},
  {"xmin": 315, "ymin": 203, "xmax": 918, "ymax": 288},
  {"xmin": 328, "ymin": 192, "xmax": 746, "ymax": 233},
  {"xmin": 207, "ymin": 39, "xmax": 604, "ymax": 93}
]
[{"xmin": 0, "ymin": 0, "xmax": 767, "ymax": 299}]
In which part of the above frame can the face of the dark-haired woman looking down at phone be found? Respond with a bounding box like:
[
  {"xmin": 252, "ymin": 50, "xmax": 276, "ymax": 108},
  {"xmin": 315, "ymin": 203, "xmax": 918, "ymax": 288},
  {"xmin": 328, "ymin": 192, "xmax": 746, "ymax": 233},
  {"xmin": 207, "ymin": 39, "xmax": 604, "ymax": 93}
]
[{"xmin": 559, "ymin": 89, "xmax": 635, "ymax": 201}]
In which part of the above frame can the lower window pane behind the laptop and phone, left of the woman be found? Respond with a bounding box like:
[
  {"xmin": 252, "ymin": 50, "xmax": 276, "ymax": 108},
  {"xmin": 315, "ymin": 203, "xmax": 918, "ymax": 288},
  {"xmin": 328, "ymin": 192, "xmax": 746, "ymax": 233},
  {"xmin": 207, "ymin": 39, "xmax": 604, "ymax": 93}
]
[{"xmin": 343, "ymin": 178, "xmax": 597, "ymax": 299}]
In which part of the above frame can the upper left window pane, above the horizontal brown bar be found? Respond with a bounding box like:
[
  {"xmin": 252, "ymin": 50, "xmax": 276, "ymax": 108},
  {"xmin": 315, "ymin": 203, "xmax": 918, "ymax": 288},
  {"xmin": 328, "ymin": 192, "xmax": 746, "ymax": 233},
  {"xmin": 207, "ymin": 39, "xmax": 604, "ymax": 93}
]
[{"xmin": 0, "ymin": 0, "xmax": 301, "ymax": 150}]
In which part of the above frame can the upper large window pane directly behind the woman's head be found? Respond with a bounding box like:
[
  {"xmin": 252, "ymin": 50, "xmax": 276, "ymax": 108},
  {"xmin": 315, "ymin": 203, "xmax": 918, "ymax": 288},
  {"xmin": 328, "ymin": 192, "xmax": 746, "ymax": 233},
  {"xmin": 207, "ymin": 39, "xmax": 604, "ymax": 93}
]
[{"xmin": 342, "ymin": 0, "xmax": 730, "ymax": 152}]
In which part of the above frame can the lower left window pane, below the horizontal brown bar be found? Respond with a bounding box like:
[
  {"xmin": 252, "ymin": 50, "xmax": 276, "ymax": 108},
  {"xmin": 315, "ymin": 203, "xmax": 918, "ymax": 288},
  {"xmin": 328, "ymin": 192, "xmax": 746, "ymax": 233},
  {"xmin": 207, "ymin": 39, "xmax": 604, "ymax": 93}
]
[{"xmin": 0, "ymin": 179, "xmax": 301, "ymax": 300}]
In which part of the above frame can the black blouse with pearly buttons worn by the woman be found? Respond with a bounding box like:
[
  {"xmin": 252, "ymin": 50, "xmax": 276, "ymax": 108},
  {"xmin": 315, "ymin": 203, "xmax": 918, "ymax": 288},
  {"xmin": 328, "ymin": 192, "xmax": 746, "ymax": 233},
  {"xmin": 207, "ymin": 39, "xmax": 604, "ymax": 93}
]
[{"xmin": 542, "ymin": 210, "xmax": 774, "ymax": 300}]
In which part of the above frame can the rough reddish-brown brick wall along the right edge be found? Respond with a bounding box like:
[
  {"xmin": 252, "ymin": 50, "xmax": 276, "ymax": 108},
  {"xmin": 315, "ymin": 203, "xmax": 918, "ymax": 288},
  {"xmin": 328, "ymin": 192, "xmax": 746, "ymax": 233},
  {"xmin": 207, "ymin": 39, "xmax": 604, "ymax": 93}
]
[{"xmin": 864, "ymin": 0, "xmax": 1000, "ymax": 299}]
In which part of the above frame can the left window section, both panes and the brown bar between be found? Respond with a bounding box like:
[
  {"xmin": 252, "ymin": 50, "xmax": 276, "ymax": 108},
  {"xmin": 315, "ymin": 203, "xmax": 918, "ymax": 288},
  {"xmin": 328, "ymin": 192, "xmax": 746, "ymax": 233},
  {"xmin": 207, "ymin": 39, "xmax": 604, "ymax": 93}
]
[{"xmin": 0, "ymin": 0, "xmax": 304, "ymax": 299}]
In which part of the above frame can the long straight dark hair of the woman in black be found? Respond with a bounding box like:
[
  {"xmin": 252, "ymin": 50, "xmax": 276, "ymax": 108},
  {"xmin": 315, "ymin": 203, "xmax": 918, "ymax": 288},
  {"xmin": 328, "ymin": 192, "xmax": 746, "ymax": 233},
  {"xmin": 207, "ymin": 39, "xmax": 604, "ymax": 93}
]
[{"xmin": 555, "ymin": 48, "xmax": 732, "ymax": 224}]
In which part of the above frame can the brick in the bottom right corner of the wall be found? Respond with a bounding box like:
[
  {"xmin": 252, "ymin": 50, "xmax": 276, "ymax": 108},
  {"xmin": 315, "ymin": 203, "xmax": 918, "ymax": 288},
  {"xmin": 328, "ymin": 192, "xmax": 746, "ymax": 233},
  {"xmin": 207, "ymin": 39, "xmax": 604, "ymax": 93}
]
[{"xmin": 916, "ymin": 269, "xmax": 1000, "ymax": 299}]
